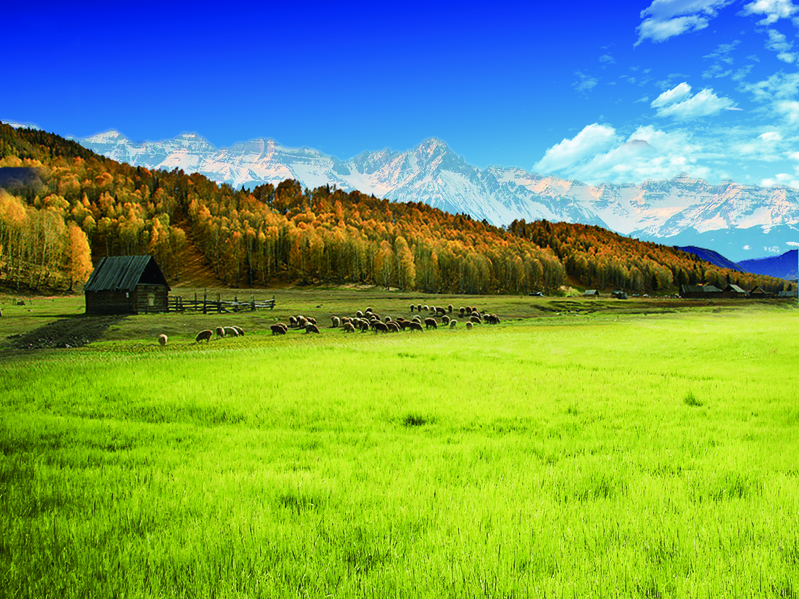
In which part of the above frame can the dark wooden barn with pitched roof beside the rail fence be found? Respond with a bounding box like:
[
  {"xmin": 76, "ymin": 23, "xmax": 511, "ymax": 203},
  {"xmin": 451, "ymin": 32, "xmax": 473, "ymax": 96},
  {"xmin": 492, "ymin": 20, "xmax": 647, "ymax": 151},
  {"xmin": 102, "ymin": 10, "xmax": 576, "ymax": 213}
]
[{"xmin": 83, "ymin": 256, "xmax": 170, "ymax": 314}]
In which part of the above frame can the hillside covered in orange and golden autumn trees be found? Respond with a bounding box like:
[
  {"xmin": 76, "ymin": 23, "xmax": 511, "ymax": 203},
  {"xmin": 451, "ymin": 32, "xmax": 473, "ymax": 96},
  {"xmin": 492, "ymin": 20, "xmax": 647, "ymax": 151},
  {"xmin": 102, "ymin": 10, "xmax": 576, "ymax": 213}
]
[{"xmin": 0, "ymin": 124, "xmax": 784, "ymax": 293}]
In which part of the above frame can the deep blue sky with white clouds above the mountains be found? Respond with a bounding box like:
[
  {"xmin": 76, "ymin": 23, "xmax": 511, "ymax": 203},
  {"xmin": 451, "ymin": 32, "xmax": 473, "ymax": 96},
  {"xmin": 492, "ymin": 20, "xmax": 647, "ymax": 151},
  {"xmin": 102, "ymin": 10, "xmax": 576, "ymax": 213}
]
[{"xmin": 0, "ymin": 0, "xmax": 799, "ymax": 187}]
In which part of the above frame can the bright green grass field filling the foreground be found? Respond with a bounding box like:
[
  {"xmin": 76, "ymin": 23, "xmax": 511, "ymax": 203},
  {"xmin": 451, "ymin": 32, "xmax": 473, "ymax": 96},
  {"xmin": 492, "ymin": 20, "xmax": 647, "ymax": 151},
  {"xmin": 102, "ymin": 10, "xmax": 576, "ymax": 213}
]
[{"xmin": 0, "ymin": 292, "xmax": 799, "ymax": 597}]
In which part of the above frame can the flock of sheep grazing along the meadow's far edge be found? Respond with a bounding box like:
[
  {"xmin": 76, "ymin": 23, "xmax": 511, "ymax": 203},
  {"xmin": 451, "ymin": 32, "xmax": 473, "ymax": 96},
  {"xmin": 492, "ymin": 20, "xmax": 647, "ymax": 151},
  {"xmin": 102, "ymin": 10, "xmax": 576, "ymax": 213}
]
[{"xmin": 166, "ymin": 304, "xmax": 500, "ymax": 346}]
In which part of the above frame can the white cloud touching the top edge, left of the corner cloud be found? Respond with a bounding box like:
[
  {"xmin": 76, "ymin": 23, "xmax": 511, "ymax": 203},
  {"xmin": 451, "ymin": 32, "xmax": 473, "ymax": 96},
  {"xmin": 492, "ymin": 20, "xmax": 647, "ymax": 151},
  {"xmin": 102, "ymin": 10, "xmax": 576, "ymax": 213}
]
[{"xmin": 635, "ymin": 0, "xmax": 732, "ymax": 46}]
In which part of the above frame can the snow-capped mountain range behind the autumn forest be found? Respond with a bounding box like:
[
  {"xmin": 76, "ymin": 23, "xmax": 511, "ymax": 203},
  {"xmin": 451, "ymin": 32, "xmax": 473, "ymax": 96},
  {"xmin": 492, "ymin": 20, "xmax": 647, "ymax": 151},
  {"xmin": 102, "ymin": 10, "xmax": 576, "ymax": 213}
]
[{"xmin": 76, "ymin": 131, "xmax": 799, "ymax": 260}]
